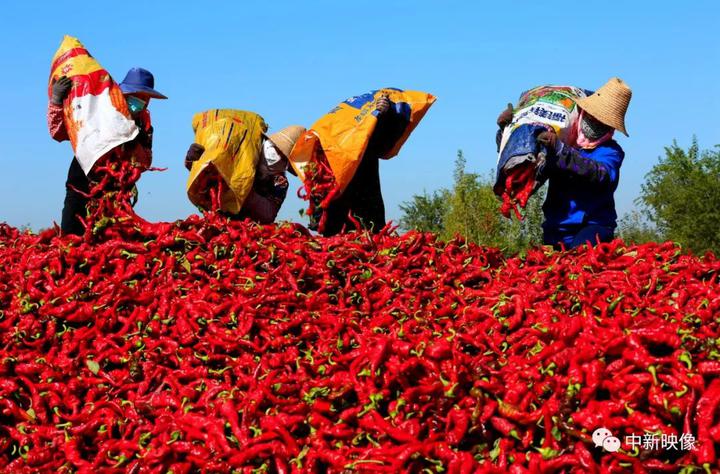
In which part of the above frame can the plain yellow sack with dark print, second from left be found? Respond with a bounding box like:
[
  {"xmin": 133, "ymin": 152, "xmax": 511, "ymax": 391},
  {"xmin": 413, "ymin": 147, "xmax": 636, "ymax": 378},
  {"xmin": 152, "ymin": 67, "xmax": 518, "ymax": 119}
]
[{"xmin": 187, "ymin": 109, "xmax": 267, "ymax": 214}]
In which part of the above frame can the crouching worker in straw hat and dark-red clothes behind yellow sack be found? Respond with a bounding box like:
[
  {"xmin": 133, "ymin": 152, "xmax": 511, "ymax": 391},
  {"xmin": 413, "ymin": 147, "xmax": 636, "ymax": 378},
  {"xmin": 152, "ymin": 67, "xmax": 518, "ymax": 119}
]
[{"xmin": 185, "ymin": 125, "xmax": 305, "ymax": 224}]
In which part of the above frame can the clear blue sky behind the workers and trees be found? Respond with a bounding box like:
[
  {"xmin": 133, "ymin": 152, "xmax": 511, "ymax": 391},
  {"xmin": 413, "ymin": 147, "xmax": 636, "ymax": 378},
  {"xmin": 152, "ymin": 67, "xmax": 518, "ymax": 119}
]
[{"xmin": 0, "ymin": 0, "xmax": 720, "ymax": 229}]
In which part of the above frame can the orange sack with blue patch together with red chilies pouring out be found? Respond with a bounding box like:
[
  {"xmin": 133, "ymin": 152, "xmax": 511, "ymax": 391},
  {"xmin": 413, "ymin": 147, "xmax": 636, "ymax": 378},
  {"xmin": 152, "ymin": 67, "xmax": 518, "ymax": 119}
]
[{"xmin": 289, "ymin": 88, "xmax": 435, "ymax": 230}]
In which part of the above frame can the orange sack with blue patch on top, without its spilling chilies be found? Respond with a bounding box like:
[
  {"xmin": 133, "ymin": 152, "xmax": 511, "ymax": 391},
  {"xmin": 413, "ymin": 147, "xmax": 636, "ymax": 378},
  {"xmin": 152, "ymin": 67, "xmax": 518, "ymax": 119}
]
[{"xmin": 289, "ymin": 88, "xmax": 435, "ymax": 195}]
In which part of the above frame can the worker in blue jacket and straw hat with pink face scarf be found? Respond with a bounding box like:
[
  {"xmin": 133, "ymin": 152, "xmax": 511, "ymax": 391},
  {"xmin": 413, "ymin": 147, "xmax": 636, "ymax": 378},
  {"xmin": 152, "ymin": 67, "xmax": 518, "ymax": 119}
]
[{"xmin": 497, "ymin": 77, "xmax": 632, "ymax": 249}]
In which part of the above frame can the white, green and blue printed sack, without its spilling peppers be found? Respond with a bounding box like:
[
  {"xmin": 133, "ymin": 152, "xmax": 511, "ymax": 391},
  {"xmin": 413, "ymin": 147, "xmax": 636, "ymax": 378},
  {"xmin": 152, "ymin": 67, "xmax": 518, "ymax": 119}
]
[{"xmin": 494, "ymin": 86, "xmax": 587, "ymax": 196}]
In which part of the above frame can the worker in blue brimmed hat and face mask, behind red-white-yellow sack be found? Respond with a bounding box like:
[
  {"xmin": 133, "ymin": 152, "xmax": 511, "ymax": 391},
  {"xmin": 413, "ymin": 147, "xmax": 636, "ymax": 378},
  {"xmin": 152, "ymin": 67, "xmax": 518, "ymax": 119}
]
[{"xmin": 47, "ymin": 67, "xmax": 167, "ymax": 235}]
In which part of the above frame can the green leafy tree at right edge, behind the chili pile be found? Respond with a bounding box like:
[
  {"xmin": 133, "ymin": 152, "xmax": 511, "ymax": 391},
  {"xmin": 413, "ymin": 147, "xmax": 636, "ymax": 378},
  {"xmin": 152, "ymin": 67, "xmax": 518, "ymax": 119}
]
[{"xmin": 638, "ymin": 139, "xmax": 720, "ymax": 254}]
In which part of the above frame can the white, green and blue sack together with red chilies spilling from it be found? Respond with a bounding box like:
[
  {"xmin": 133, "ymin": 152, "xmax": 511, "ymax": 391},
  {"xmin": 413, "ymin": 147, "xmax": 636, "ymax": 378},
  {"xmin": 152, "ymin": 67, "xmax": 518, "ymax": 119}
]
[{"xmin": 493, "ymin": 86, "xmax": 587, "ymax": 219}]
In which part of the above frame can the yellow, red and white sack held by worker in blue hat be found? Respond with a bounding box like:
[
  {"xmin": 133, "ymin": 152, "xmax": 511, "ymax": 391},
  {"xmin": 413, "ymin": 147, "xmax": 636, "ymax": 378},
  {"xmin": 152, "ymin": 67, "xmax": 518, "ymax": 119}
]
[{"xmin": 48, "ymin": 36, "xmax": 138, "ymax": 174}]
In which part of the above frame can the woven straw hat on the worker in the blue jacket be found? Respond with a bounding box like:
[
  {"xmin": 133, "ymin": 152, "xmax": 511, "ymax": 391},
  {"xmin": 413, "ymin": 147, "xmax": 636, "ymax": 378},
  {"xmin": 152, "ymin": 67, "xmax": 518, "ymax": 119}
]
[{"xmin": 577, "ymin": 77, "xmax": 632, "ymax": 136}]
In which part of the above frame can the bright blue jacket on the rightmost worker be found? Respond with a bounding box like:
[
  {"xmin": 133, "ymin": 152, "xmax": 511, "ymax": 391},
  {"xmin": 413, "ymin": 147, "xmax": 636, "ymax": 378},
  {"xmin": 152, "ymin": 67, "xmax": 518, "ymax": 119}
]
[{"xmin": 543, "ymin": 140, "xmax": 625, "ymax": 229}]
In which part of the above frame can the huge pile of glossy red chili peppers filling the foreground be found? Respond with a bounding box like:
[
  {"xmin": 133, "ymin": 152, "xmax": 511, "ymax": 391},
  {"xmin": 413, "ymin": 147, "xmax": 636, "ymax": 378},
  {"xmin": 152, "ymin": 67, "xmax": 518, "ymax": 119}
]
[{"xmin": 0, "ymin": 161, "xmax": 720, "ymax": 474}]
